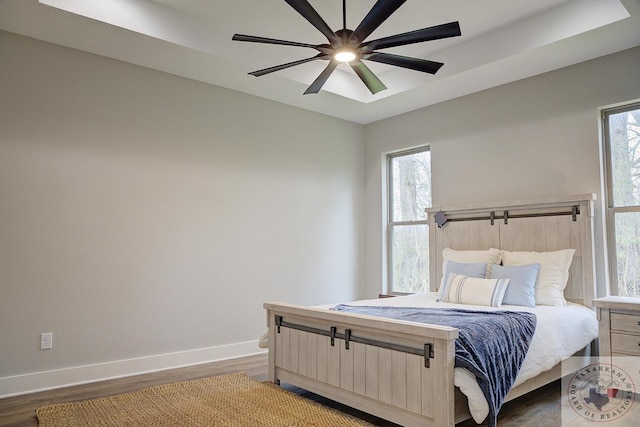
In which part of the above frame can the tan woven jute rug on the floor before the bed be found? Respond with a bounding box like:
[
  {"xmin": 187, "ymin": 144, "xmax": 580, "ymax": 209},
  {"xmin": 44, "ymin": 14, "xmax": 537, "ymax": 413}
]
[{"xmin": 36, "ymin": 373, "xmax": 371, "ymax": 427}]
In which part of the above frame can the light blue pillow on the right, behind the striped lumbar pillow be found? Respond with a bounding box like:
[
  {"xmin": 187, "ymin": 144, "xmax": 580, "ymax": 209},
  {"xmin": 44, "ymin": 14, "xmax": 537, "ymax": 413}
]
[{"xmin": 491, "ymin": 264, "xmax": 540, "ymax": 307}]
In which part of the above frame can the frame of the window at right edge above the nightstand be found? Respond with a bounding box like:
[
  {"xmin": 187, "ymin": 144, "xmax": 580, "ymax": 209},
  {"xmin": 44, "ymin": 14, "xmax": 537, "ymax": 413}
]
[{"xmin": 601, "ymin": 101, "xmax": 640, "ymax": 295}]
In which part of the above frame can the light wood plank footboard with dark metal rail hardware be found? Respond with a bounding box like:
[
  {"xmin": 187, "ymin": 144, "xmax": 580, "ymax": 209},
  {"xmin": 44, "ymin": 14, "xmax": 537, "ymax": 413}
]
[{"xmin": 264, "ymin": 303, "xmax": 458, "ymax": 427}]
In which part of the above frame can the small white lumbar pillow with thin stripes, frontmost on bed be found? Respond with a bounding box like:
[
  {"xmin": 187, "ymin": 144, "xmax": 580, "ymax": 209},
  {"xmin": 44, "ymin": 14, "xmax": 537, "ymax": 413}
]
[{"xmin": 439, "ymin": 273, "xmax": 509, "ymax": 307}]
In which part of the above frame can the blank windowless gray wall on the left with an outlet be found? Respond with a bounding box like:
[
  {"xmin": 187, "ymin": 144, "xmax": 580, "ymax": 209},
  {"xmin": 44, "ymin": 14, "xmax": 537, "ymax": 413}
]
[{"xmin": 0, "ymin": 32, "xmax": 364, "ymax": 395}]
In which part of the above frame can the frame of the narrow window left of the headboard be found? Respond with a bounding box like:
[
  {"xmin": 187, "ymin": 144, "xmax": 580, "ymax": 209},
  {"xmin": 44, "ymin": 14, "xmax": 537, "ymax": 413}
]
[{"xmin": 385, "ymin": 145, "xmax": 431, "ymax": 295}]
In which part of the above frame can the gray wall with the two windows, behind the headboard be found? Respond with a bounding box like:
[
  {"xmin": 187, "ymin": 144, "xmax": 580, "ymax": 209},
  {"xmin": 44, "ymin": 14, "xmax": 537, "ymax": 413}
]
[{"xmin": 365, "ymin": 48, "xmax": 640, "ymax": 294}]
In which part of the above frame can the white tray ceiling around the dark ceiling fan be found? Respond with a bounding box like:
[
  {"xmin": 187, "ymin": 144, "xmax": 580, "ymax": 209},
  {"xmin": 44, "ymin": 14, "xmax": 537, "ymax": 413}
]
[{"xmin": 0, "ymin": 0, "xmax": 640, "ymax": 123}]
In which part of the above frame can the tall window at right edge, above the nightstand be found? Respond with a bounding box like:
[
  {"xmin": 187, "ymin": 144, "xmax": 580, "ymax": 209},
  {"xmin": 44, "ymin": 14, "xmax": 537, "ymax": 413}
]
[{"xmin": 603, "ymin": 103, "xmax": 640, "ymax": 297}]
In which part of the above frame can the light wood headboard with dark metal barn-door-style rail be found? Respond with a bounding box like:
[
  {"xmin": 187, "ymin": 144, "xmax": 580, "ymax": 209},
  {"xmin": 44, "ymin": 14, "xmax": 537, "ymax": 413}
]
[{"xmin": 426, "ymin": 194, "xmax": 596, "ymax": 307}]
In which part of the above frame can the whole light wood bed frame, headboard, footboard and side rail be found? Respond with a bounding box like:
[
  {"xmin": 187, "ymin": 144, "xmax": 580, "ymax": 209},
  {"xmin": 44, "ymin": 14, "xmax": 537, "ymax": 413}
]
[{"xmin": 264, "ymin": 194, "xmax": 595, "ymax": 427}]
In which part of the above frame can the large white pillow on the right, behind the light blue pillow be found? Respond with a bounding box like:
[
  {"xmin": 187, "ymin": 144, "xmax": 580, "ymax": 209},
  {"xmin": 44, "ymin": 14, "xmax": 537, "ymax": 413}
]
[{"xmin": 502, "ymin": 249, "xmax": 575, "ymax": 306}]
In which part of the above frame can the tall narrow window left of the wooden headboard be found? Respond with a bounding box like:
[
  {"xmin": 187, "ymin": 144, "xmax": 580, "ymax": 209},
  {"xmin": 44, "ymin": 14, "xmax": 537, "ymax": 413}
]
[{"xmin": 387, "ymin": 147, "xmax": 431, "ymax": 293}]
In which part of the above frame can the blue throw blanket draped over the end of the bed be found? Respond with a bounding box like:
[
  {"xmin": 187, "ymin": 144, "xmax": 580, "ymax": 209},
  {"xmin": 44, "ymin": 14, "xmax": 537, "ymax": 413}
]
[{"xmin": 332, "ymin": 304, "xmax": 536, "ymax": 427}]
